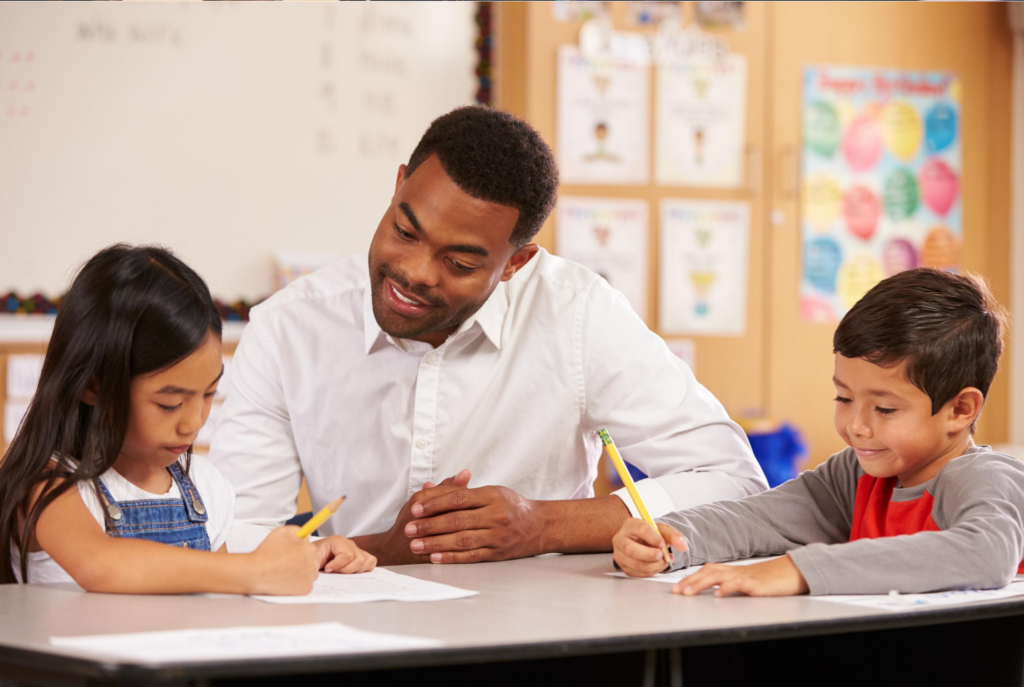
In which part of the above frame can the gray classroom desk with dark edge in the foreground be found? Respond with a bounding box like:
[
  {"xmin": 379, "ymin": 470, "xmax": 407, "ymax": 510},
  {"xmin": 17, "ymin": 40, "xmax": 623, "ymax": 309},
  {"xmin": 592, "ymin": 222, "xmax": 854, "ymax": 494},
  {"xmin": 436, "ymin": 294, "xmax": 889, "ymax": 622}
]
[{"xmin": 0, "ymin": 554, "xmax": 1024, "ymax": 685}]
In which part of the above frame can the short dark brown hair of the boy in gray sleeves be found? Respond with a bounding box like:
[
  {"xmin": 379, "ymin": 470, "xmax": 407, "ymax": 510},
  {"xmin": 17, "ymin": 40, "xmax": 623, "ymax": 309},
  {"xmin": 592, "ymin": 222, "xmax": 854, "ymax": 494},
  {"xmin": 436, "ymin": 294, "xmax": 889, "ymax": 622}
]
[{"xmin": 833, "ymin": 267, "xmax": 1007, "ymax": 432}]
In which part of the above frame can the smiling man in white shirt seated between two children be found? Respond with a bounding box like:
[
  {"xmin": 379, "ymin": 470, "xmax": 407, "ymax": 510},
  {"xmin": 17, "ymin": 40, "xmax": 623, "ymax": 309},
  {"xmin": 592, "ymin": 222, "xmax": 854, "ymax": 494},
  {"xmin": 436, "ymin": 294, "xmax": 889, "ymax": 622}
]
[{"xmin": 211, "ymin": 108, "xmax": 767, "ymax": 565}]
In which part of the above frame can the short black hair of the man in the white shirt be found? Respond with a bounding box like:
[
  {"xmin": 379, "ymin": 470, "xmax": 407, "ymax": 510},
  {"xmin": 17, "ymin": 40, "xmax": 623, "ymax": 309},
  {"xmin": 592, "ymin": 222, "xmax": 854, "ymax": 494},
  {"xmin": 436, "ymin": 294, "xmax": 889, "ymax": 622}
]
[{"xmin": 406, "ymin": 105, "xmax": 558, "ymax": 250}]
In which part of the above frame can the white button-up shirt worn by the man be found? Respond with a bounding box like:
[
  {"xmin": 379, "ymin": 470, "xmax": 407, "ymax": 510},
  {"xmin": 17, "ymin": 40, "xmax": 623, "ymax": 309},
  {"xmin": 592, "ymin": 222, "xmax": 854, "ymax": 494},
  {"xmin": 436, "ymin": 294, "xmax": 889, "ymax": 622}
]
[{"xmin": 210, "ymin": 250, "xmax": 767, "ymax": 551}]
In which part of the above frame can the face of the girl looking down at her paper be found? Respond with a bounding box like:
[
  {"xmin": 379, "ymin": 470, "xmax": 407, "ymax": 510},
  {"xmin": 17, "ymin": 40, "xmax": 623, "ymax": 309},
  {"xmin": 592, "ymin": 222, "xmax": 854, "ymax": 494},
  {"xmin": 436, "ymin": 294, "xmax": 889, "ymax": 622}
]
[{"xmin": 119, "ymin": 333, "xmax": 224, "ymax": 468}]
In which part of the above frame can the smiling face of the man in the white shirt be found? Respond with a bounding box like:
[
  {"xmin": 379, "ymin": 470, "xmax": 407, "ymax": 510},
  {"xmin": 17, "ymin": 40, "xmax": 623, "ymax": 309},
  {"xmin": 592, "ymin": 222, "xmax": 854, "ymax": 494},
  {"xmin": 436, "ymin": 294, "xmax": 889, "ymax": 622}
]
[{"xmin": 370, "ymin": 156, "xmax": 538, "ymax": 346}]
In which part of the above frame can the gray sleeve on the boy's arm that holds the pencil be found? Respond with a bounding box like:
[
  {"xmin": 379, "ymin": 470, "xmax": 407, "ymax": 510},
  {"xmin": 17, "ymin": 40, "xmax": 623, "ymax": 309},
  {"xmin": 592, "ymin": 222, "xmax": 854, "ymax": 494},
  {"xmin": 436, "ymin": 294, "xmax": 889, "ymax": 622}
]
[{"xmin": 657, "ymin": 449, "xmax": 858, "ymax": 570}]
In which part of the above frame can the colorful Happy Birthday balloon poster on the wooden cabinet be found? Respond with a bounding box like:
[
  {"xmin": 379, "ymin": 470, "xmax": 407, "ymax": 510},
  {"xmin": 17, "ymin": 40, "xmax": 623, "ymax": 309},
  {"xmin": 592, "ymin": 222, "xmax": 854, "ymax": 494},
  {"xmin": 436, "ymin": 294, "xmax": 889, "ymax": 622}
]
[{"xmin": 800, "ymin": 67, "xmax": 963, "ymax": 321}]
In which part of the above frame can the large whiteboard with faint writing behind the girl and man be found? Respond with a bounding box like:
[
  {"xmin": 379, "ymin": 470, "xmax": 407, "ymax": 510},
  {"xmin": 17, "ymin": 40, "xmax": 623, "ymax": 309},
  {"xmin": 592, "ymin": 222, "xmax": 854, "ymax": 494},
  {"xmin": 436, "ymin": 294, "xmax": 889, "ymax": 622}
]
[{"xmin": 0, "ymin": 2, "xmax": 476, "ymax": 300}]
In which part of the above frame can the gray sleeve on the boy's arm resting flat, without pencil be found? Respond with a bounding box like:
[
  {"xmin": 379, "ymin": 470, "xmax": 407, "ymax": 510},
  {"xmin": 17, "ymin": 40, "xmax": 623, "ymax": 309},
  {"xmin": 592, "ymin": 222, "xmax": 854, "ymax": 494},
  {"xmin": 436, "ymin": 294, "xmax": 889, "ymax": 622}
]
[{"xmin": 790, "ymin": 453, "xmax": 1024, "ymax": 594}]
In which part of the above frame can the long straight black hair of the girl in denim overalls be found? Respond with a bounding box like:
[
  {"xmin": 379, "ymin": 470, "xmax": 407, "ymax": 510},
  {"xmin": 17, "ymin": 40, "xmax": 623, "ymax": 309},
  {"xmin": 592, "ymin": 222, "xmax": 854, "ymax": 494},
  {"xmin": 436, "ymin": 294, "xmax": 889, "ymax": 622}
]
[{"xmin": 0, "ymin": 244, "xmax": 221, "ymax": 584}]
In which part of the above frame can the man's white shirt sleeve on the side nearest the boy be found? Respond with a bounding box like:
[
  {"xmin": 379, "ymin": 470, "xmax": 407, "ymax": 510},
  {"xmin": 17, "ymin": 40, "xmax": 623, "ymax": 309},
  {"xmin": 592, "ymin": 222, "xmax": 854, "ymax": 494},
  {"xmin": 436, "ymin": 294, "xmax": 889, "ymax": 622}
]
[{"xmin": 575, "ymin": 276, "xmax": 768, "ymax": 517}]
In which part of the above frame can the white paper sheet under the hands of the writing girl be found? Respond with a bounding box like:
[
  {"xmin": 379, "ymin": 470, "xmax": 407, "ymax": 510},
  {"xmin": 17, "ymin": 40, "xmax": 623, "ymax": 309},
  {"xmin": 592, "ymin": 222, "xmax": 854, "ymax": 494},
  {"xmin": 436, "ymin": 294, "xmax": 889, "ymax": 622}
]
[{"xmin": 253, "ymin": 568, "xmax": 479, "ymax": 604}]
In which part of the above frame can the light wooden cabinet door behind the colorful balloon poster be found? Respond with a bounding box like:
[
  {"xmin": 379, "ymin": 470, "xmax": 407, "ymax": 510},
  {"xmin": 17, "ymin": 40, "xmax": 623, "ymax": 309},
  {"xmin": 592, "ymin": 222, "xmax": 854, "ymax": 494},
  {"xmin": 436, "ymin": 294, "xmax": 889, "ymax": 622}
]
[{"xmin": 765, "ymin": 2, "xmax": 1012, "ymax": 465}]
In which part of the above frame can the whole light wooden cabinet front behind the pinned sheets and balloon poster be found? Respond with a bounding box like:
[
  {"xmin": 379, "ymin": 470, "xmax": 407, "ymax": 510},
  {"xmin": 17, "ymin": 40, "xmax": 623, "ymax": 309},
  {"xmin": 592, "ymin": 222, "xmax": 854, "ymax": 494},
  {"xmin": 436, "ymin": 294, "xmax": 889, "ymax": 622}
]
[{"xmin": 497, "ymin": 2, "xmax": 1012, "ymax": 467}]
